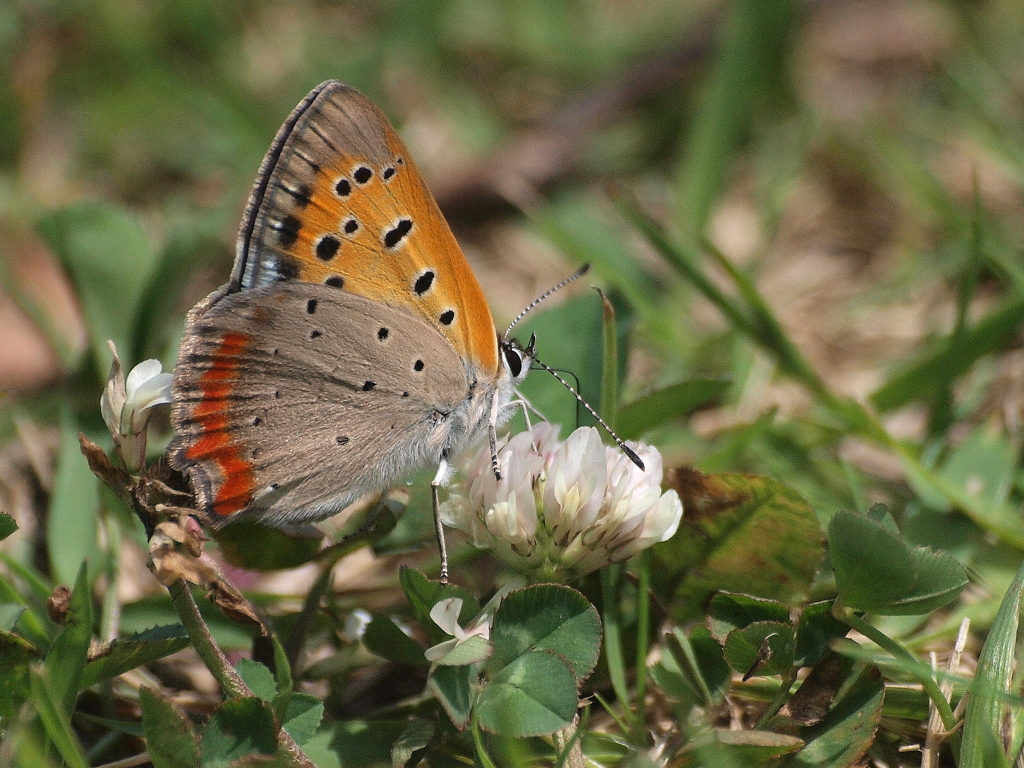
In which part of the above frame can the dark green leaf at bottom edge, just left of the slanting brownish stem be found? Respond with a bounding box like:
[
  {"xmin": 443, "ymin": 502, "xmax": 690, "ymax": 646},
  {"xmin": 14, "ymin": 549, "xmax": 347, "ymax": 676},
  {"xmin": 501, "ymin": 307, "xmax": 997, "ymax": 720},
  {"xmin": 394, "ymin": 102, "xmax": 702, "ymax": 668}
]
[{"xmin": 203, "ymin": 696, "xmax": 278, "ymax": 768}]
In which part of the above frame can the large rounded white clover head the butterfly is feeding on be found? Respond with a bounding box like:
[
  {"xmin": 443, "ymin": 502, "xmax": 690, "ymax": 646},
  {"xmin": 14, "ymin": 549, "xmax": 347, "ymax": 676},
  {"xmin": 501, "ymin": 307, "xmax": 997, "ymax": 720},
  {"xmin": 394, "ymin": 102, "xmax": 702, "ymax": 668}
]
[{"xmin": 441, "ymin": 423, "xmax": 683, "ymax": 579}]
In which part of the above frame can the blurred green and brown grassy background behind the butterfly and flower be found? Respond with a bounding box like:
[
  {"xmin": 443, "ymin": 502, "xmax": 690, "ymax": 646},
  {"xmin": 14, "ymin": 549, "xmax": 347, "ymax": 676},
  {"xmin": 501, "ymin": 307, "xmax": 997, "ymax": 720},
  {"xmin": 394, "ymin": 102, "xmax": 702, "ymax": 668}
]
[{"xmin": 0, "ymin": 0, "xmax": 1024, "ymax": 626}]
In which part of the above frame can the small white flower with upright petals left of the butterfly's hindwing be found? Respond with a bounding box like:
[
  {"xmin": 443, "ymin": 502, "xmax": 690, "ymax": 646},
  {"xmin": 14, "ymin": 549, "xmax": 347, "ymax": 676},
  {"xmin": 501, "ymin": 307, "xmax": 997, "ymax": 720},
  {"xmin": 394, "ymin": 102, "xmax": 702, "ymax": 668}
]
[{"xmin": 99, "ymin": 342, "xmax": 173, "ymax": 471}]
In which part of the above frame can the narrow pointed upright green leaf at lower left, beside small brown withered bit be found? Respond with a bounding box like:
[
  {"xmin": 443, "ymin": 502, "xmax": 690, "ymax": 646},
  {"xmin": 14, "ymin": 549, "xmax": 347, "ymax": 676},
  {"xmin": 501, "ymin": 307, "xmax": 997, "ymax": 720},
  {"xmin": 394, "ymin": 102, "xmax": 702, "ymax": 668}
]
[{"xmin": 44, "ymin": 562, "xmax": 92, "ymax": 717}]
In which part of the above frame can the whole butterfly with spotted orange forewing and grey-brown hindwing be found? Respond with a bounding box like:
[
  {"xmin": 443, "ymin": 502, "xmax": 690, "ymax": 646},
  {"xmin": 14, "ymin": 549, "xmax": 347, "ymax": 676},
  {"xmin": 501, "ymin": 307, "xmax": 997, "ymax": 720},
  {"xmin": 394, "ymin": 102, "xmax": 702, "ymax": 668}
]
[{"xmin": 169, "ymin": 81, "xmax": 534, "ymax": 573}]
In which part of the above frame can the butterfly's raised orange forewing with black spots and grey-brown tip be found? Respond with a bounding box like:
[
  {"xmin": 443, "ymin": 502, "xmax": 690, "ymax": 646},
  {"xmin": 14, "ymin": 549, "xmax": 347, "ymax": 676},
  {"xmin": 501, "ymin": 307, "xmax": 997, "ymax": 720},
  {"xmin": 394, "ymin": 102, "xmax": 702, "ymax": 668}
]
[{"xmin": 228, "ymin": 81, "xmax": 499, "ymax": 377}]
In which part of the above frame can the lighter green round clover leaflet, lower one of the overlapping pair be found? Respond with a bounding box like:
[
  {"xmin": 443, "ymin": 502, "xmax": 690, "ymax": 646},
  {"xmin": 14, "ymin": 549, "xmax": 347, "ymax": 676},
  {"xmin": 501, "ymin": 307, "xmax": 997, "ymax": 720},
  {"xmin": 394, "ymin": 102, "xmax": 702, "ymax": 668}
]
[{"xmin": 475, "ymin": 651, "xmax": 579, "ymax": 737}]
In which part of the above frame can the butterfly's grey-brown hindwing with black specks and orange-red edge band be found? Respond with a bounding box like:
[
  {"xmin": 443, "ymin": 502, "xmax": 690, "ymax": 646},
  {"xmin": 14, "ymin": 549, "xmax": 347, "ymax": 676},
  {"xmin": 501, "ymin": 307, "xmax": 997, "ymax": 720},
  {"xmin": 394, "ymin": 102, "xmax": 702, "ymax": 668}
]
[{"xmin": 170, "ymin": 283, "xmax": 470, "ymax": 524}]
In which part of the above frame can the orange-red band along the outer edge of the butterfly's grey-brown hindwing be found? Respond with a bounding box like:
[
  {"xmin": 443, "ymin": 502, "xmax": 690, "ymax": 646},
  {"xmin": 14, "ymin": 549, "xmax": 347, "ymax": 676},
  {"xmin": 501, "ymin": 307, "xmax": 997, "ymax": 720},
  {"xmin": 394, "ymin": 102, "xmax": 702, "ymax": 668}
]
[{"xmin": 185, "ymin": 333, "xmax": 256, "ymax": 517}]
